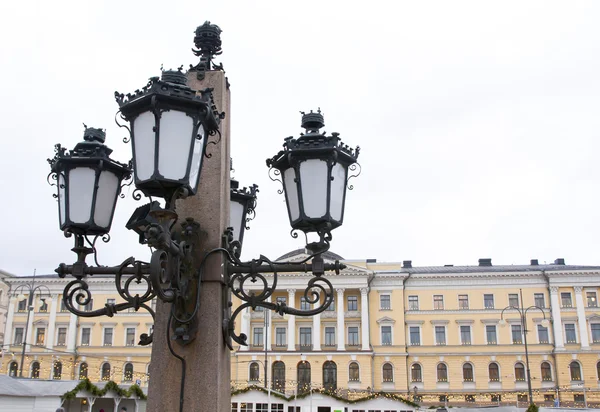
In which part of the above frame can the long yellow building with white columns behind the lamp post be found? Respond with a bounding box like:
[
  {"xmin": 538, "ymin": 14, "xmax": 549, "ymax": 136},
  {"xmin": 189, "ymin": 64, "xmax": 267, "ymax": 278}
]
[{"xmin": 1, "ymin": 250, "xmax": 600, "ymax": 405}]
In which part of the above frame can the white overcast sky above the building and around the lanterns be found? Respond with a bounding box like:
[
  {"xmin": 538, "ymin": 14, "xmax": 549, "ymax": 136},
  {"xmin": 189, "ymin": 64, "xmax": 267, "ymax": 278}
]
[{"xmin": 0, "ymin": 0, "xmax": 600, "ymax": 275}]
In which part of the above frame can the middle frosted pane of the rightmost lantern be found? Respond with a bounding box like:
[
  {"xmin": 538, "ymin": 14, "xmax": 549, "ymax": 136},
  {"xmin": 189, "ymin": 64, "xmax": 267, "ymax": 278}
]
[{"xmin": 300, "ymin": 159, "xmax": 327, "ymax": 218}]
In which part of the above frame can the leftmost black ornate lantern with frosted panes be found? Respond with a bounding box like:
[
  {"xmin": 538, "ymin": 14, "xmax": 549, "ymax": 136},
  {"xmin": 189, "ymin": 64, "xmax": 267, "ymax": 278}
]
[{"xmin": 48, "ymin": 127, "xmax": 131, "ymax": 235}]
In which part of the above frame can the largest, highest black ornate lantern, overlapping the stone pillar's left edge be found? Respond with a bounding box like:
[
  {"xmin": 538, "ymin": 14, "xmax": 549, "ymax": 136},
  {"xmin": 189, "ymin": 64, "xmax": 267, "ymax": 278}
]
[{"xmin": 115, "ymin": 69, "xmax": 220, "ymax": 199}]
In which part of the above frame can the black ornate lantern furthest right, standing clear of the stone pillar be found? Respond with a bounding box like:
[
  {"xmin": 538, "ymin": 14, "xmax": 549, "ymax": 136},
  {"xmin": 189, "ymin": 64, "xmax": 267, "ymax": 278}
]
[{"xmin": 267, "ymin": 110, "xmax": 360, "ymax": 233}]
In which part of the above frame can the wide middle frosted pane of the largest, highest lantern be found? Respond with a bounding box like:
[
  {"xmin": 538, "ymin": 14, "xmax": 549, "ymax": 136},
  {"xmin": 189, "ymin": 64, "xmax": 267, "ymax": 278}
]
[{"xmin": 158, "ymin": 110, "xmax": 194, "ymax": 180}]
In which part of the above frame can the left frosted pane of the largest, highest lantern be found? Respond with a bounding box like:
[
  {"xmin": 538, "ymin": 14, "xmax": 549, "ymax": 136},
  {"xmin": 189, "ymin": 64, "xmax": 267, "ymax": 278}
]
[{"xmin": 133, "ymin": 112, "xmax": 156, "ymax": 180}]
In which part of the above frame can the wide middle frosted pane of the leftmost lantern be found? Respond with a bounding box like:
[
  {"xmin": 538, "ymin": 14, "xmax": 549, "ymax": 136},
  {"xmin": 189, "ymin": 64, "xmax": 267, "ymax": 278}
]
[{"xmin": 69, "ymin": 167, "xmax": 96, "ymax": 223}]
